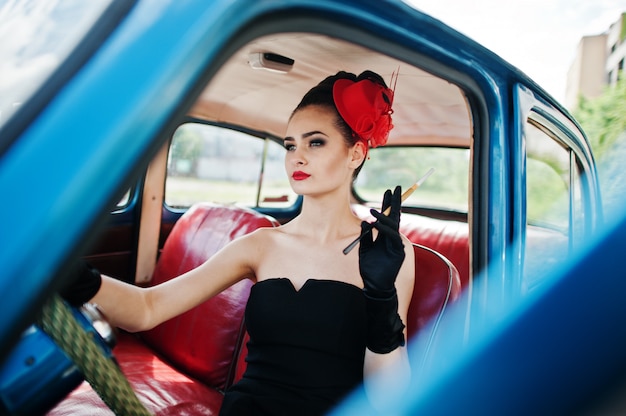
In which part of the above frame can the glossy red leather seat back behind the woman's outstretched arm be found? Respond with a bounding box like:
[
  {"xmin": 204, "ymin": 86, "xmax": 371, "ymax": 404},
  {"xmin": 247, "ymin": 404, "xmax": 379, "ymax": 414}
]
[{"xmin": 141, "ymin": 203, "xmax": 279, "ymax": 389}]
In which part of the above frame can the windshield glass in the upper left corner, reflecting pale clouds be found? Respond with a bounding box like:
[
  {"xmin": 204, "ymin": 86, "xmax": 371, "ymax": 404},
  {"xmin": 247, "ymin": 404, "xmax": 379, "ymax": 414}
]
[{"xmin": 0, "ymin": 0, "xmax": 111, "ymax": 127}]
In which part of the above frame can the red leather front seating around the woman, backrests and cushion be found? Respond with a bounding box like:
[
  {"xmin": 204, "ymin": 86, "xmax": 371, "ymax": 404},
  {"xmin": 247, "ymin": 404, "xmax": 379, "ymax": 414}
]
[{"xmin": 49, "ymin": 204, "xmax": 461, "ymax": 416}]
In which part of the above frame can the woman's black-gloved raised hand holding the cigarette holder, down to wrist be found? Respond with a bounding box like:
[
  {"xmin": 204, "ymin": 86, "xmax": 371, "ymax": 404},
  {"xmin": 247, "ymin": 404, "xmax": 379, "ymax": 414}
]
[{"xmin": 359, "ymin": 186, "xmax": 405, "ymax": 299}]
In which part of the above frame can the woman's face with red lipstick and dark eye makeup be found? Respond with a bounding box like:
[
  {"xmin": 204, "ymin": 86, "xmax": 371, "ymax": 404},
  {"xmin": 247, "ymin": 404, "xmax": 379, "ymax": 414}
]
[{"xmin": 284, "ymin": 106, "xmax": 364, "ymax": 195}]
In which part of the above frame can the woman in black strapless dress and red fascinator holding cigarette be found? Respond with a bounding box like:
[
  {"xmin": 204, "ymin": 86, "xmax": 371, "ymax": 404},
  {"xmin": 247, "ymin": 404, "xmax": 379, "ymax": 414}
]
[{"xmin": 63, "ymin": 71, "xmax": 414, "ymax": 415}]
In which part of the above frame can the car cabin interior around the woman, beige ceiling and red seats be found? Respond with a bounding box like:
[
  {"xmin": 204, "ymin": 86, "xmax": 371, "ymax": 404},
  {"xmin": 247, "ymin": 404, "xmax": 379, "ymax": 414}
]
[{"xmin": 48, "ymin": 32, "xmax": 473, "ymax": 415}]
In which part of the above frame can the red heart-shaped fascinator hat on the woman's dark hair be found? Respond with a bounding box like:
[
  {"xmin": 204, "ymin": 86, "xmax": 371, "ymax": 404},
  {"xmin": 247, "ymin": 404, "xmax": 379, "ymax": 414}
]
[{"xmin": 333, "ymin": 75, "xmax": 393, "ymax": 147}]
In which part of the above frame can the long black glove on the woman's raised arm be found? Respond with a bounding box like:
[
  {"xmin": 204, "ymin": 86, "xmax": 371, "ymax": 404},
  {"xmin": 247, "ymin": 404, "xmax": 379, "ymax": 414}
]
[{"xmin": 359, "ymin": 186, "xmax": 405, "ymax": 354}]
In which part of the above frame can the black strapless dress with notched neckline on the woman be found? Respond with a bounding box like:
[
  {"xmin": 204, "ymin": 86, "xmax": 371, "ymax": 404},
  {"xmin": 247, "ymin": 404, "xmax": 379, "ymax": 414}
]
[{"xmin": 220, "ymin": 278, "xmax": 366, "ymax": 416}]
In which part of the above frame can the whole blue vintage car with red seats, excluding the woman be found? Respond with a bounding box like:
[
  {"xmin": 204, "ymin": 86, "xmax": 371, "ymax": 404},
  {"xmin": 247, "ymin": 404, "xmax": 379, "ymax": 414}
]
[{"xmin": 0, "ymin": 0, "xmax": 612, "ymax": 416}]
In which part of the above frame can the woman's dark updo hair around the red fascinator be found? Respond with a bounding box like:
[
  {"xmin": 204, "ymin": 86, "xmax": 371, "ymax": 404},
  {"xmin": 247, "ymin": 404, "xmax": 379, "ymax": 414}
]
[{"xmin": 290, "ymin": 71, "xmax": 387, "ymax": 179}]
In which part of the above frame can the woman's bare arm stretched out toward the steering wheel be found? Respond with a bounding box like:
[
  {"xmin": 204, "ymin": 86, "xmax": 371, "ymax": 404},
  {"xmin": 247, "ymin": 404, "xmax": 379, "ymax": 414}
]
[{"xmin": 91, "ymin": 230, "xmax": 266, "ymax": 332}]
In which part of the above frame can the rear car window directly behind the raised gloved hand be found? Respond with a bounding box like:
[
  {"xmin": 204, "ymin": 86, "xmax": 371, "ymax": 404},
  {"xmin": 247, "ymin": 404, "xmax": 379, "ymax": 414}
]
[{"xmin": 355, "ymin": 146, "xmax": 470, "ymax": 213}]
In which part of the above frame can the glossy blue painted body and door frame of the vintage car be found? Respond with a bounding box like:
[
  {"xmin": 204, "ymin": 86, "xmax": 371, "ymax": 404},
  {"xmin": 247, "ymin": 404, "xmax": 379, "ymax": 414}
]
[{"xmin": 0, "ymin": 0, "xmax": 626, "ymax": 414}]
